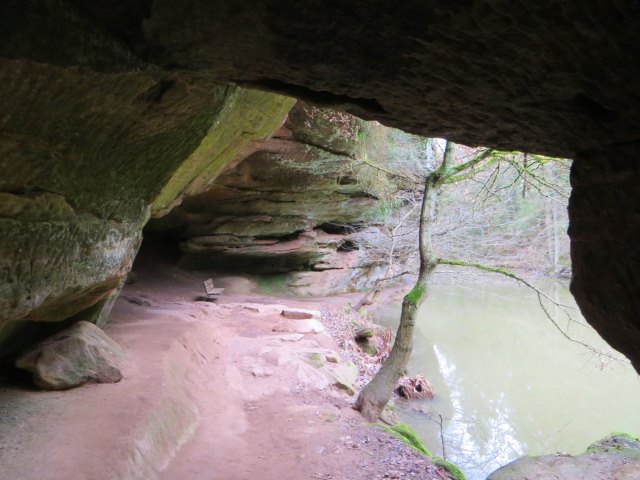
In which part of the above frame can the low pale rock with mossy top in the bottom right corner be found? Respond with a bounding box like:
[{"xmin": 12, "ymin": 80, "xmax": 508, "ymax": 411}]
[{"xmin": 487, "ymin": 434, "xmax": 640, "ymax": 480}]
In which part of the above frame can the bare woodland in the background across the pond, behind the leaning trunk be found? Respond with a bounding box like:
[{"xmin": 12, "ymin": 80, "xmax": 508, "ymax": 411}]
[{"xmin": 349, "ymin": 122, "xmax": 571, "ymax": 284}]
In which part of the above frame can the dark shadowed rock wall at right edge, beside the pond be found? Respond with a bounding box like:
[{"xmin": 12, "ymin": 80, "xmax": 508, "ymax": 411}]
[{"xmin": 569, "ymin": 145, "xmax": 640, "ymax": 372}]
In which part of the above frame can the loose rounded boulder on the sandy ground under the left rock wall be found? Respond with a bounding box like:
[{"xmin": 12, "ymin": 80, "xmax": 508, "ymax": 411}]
[{"xmin": 15, "ymin": 321, "xmax": 124, "ymax": 390}]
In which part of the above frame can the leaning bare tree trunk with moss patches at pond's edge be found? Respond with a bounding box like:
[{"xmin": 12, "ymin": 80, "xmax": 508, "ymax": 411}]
[{"xmin": 355, "ymin": 142, "xmax": 455, "ymax": 422}]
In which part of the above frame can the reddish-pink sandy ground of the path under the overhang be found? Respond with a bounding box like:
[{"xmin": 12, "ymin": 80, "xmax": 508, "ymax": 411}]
[{"xmin": 0, "ymin": 265, "xmax": 446, "ymax": 480}]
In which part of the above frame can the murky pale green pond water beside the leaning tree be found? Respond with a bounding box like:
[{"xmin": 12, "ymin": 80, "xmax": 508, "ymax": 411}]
[{"xmin": 381, "ymin": 277, "xmax": 640, "ymax": 480}]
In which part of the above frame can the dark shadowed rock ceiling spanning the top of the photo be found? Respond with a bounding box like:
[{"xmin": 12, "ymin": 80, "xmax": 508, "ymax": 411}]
[{"xmin": 0, "ymin": 0, "xmax": 640, "ymax": 157}]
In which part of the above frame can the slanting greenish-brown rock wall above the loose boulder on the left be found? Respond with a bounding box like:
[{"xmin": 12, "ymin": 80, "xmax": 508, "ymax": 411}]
[{"xmin": 0, "ymin": 75, "xmax": 292, "ymax": 357}]
